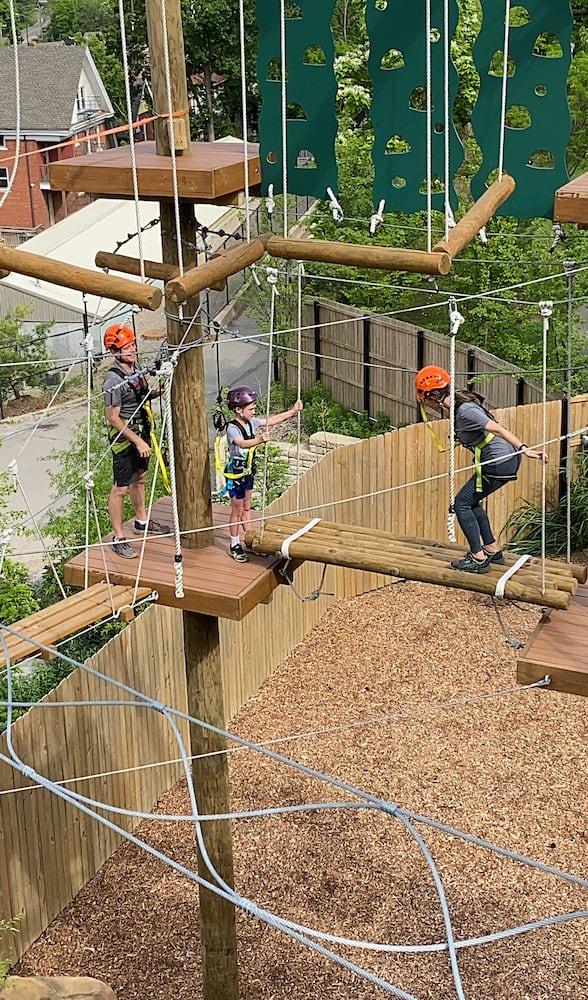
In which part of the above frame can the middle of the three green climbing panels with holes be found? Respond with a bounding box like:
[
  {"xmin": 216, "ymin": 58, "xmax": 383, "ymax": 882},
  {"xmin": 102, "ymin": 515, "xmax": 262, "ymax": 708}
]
[{"xmin": 366, "ymin": 0, "xmax": 463, "ymax": 212}]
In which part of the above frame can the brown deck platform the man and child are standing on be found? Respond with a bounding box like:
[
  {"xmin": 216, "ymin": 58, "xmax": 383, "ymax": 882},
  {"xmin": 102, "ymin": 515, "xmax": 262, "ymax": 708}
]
[{"xmin": 64, "ymin": 497, "xmax": 284, "ymax": 621}]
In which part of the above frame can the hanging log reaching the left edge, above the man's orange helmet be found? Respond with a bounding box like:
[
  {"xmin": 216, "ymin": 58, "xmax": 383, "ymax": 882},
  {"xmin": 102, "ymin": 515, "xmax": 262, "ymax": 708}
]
[{"xmin": 0, "ymin": 246, "xmax": 163, "ymax": 311}]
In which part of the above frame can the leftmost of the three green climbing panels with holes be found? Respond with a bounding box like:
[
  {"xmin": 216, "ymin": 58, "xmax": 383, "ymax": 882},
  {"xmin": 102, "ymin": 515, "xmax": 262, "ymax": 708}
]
[{"xmin": 256, "ymin": 0, "xmax": 337, "ymax": 198}]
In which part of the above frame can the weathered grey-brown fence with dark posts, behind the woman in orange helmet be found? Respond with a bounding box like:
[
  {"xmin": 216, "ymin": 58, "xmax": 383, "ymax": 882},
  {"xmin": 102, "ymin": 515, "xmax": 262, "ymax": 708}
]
[{"xmin": 284, "ymin": 299, "xmax": 553, "ymax": 426}]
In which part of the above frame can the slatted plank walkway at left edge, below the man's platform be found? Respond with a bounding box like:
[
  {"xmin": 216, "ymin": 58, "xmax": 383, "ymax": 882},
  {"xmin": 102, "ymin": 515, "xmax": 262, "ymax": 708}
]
[{"xmin": 0, "ymin": 583, "xmax": 151, "ymax": 667}]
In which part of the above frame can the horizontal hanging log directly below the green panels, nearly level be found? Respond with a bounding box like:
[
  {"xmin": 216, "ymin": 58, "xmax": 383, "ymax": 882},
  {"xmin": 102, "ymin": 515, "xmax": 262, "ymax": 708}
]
[{"xmin": 267, "ymin": 236, "xmax": 451, "ymax": 274}]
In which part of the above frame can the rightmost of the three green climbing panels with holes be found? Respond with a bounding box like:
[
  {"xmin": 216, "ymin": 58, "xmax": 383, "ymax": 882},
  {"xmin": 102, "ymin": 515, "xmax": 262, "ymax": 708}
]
[{"xmin": 471, "ymin": 0, "xmax": 572, "ymax": 218}]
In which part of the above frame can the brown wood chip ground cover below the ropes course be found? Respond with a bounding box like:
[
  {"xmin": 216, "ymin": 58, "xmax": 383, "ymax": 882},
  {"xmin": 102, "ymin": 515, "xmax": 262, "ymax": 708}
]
[{"xmin": 18, "ymin": 583, "xmax": 588, "ymax": 1000}]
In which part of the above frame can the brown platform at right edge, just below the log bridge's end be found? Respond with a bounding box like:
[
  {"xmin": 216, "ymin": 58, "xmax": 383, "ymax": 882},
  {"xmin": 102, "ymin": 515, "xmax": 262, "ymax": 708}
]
[{"xmin": 517, "ymin": 584, "xmax": 588, "ymax": 695}]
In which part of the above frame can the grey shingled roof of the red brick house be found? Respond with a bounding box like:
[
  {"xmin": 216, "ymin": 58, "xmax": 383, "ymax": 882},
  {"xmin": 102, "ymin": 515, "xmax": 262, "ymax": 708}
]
[{"xmin": 0, "ymin": 42, "xmax": 107, "ymax": 133}]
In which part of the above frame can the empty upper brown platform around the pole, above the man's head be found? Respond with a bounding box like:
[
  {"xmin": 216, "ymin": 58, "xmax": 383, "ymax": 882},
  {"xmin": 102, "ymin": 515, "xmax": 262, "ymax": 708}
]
[{"xmin": 49, "ymin": 142, "xmax": 261, "ymax": 205}]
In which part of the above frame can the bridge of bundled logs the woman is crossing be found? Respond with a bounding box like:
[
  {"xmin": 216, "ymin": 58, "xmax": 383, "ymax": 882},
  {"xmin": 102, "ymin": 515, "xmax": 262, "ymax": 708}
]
[{"xmin": 245, "ymin": 515, "xmax": 588, "ymax": 610}]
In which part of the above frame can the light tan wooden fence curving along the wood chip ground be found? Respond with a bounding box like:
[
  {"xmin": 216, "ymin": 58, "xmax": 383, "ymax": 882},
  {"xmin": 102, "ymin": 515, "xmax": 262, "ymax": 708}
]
[{"xmin": 0, "ymin": 396, "xmax": 588, "ymax": 957}]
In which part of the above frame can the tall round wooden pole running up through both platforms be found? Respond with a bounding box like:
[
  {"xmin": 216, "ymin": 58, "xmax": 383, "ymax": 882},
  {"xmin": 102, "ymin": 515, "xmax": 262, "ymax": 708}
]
[{"xmin": 146, "ymin": 0, "xmax": 239, "ymax": 1000}]
